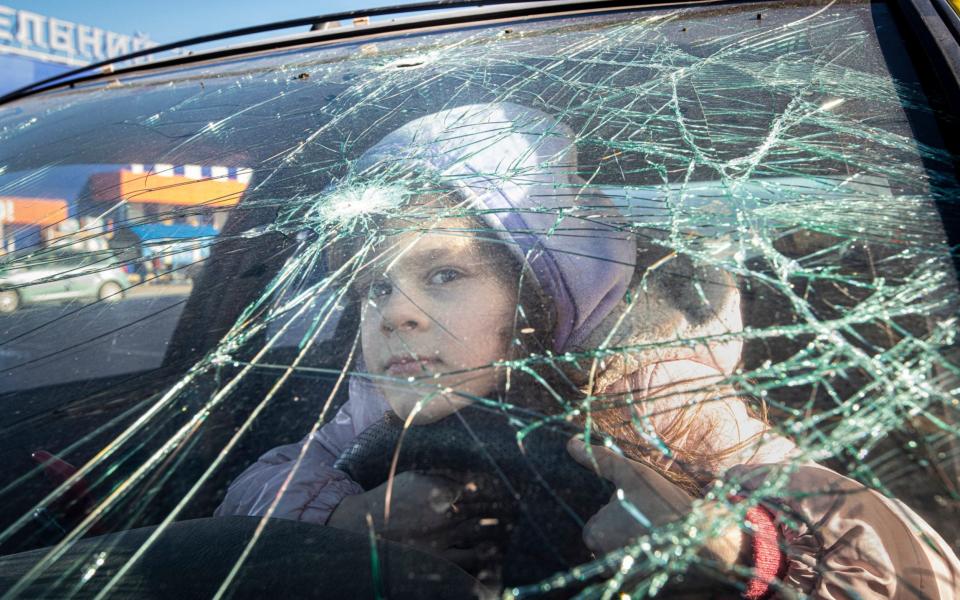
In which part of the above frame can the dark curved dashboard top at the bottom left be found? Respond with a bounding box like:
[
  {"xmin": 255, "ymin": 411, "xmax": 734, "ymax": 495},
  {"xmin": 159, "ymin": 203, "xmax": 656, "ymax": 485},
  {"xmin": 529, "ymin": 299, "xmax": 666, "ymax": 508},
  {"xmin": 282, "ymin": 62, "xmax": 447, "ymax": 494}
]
[{"xmin": 0, "ymin": 517, "xmax": 485, "ymax": 599}]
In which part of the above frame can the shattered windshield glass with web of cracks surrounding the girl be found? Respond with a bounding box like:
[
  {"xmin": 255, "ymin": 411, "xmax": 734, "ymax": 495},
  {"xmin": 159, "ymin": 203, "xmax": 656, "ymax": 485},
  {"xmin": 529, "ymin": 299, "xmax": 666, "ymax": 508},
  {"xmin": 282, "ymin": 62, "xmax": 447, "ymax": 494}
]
[{"xmin": 0, "ymin": 2, "xmax": 960, "ymax": 597}]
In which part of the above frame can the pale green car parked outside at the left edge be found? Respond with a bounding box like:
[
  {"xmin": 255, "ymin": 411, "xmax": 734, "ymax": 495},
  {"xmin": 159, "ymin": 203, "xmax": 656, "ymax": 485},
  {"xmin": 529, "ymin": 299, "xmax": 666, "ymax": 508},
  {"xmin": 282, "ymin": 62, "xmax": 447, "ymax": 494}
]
[{"xmin": 0, "ymin": 252, "xmax": 130, "ymax": 313}]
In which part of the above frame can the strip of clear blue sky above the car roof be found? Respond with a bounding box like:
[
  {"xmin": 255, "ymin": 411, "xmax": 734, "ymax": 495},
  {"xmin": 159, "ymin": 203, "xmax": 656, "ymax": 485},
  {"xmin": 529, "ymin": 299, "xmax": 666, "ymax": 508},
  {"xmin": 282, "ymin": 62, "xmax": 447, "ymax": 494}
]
[{"xmin": 8, "ymin": 0, "xmax": 404, "ymax": 44}]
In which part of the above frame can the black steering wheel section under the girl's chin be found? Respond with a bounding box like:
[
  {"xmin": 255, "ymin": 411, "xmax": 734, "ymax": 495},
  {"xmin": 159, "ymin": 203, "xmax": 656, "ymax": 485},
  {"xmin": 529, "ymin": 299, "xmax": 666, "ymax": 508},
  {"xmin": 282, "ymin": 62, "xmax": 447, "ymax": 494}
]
[{"xmin": 334, "ymin": 405, "xmax": 614, "ymax": 587}]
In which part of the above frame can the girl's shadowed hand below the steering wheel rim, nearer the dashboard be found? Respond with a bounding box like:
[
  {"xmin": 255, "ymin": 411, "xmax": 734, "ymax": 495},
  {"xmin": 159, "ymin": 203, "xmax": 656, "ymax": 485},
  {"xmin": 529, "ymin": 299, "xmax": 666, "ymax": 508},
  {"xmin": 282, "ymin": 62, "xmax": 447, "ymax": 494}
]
[{"xmin": 327, "ymin": 471, "xmax": 498, "ymax": 569}]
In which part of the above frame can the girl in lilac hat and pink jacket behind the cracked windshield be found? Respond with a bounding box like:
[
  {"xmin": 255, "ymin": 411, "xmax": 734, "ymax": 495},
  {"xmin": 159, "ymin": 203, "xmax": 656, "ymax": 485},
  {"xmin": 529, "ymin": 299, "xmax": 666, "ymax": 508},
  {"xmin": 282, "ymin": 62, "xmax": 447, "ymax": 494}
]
[{"xmin": 217, "ymin": 104, "xmax": 960, "ymax": 598}]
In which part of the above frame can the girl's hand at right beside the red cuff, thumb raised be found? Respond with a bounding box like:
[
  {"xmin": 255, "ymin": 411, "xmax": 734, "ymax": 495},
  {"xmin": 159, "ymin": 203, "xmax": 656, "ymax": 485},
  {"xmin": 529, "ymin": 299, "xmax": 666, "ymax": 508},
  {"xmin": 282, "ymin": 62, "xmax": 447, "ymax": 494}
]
[{"xmin": 567, "ymin": 438, "xmax": 745, "ymax": 566}]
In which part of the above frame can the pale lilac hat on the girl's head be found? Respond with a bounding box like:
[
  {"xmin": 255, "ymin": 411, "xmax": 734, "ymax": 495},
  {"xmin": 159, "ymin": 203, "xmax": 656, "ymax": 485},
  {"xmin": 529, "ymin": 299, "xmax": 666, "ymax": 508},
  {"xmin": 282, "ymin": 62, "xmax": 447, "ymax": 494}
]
[{"xmin": 353, "ymin": 103, "xmax": 636, "ymax": 352}]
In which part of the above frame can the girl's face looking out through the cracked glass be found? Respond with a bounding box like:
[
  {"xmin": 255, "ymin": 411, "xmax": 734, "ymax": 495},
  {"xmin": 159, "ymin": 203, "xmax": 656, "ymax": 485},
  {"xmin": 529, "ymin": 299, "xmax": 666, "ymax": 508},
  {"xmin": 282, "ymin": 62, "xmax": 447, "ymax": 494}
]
[{"xmin": 361, "ymin": 223, "xmax": 516, "ymax": 423}]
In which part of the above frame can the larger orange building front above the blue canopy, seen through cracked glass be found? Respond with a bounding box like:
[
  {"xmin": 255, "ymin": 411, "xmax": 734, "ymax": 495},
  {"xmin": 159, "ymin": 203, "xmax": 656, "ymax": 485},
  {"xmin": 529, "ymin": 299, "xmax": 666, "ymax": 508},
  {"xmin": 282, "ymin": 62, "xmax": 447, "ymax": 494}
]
[{"xmin": 88, "ymin": 170, "xmax": 247, "ymax": 208}]
